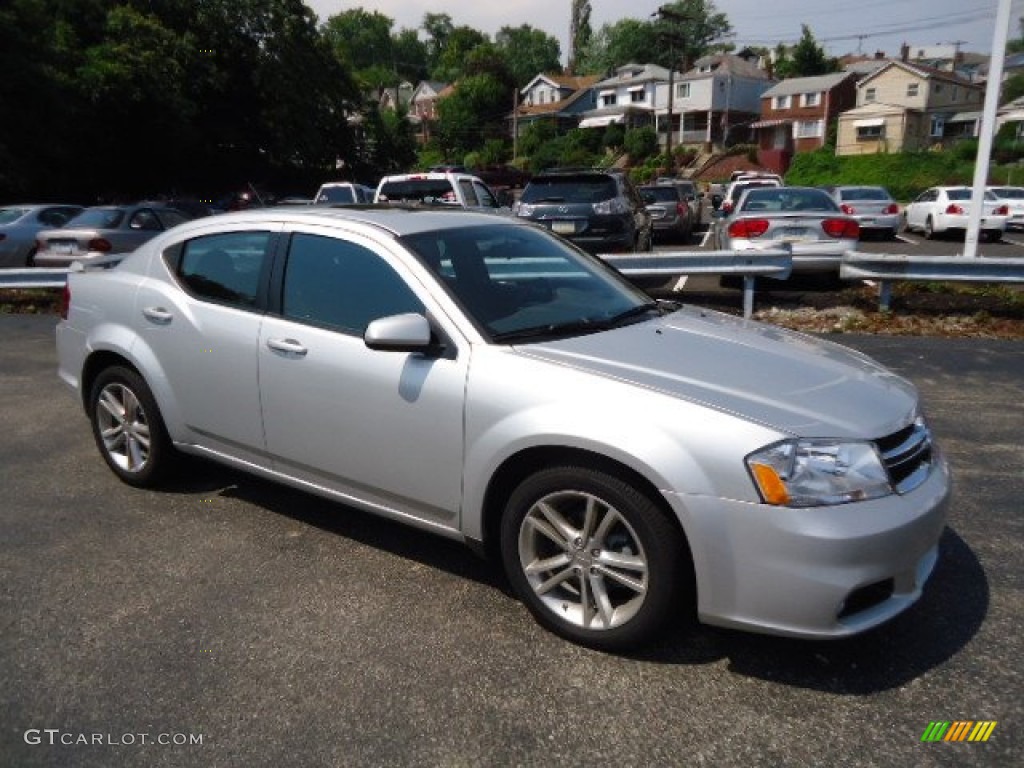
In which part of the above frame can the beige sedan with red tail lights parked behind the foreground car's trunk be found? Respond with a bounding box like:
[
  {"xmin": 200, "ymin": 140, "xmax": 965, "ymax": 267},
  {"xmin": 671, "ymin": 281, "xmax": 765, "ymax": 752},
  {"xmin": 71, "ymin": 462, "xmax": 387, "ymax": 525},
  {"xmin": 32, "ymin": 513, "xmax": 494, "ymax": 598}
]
[{"xmin": 35, "ymin": 205, "xmax": 189, "ymax": 267}]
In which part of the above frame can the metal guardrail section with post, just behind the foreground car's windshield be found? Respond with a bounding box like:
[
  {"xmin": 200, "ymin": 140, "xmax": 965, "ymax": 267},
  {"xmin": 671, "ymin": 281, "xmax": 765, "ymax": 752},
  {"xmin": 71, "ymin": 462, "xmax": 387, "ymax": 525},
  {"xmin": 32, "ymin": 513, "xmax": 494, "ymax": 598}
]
[{"xmin": 598, "ymin": 249, "xmax": 793, "ymax": 318}]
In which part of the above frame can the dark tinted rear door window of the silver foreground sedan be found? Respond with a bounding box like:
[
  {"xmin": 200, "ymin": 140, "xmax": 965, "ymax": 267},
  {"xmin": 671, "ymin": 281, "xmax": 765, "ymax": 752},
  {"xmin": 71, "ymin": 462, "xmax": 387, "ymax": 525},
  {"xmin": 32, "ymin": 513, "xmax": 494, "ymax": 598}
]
[{"xmin": 178, "ymin": 232, "xmax": 270, "ymax": 307}]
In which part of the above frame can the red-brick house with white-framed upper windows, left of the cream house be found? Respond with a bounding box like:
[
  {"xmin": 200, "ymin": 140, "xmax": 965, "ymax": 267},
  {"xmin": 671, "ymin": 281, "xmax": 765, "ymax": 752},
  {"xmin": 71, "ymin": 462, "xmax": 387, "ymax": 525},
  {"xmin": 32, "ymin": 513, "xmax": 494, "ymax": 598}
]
[{"xmin": 751, "ymin": 72, "xmax": 857, "ymax": 173}]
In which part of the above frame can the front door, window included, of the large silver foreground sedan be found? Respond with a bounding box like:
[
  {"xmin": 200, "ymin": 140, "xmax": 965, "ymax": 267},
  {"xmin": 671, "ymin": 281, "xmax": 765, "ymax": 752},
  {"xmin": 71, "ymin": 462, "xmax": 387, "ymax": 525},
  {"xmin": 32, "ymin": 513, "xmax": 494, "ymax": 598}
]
[{"xmin": 259, "ymin": 229, "xmax": 469, "ymax": 528}]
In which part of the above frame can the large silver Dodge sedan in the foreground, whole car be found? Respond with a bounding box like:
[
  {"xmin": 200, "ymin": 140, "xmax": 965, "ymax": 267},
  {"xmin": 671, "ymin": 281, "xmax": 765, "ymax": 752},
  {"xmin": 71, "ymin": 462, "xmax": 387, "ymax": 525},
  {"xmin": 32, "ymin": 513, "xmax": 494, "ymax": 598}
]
[{"xmin": 56, "ymin": 206, "xmax": 950, "ymax": 649}]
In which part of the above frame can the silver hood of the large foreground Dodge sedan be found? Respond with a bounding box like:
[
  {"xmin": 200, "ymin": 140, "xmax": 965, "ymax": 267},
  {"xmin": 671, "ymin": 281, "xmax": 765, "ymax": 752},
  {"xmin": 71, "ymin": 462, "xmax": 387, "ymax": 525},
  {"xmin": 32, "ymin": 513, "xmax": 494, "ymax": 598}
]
[{"xmin": 519, "ymin": 308, "xmax": 918, "ymax": 438}]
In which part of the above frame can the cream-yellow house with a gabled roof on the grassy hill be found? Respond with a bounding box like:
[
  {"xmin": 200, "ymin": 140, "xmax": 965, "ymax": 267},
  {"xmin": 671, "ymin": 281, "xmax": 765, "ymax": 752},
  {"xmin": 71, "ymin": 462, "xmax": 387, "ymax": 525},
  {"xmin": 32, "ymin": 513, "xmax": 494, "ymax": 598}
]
[{"xmin": 836, "ymin": 60, "xmax": 984, "ymax": 155}]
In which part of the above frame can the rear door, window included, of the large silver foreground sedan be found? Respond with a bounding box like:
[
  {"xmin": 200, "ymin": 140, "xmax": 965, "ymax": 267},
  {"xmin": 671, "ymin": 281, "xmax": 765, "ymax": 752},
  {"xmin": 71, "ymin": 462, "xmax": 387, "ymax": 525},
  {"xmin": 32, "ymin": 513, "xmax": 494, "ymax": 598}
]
[{"xmin": 135, "ymin": 225, "xmax": 274, "ymax": 462}]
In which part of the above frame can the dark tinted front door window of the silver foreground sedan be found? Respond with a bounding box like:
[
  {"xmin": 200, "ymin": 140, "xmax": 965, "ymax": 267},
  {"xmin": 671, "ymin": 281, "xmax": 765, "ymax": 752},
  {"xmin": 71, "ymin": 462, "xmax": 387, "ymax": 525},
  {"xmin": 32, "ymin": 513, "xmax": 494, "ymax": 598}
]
[{"xmin": 282, "ymin": 234, "xmax": 424, "ymax": 334}]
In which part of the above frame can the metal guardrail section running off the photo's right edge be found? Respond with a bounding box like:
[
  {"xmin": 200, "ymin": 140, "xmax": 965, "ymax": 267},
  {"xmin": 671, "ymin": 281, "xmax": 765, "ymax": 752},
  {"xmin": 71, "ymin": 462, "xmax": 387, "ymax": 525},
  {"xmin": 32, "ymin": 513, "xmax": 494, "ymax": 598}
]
[{"xmin": 839, "ymin": 251, "xmax": 1024, "ymax": 311}]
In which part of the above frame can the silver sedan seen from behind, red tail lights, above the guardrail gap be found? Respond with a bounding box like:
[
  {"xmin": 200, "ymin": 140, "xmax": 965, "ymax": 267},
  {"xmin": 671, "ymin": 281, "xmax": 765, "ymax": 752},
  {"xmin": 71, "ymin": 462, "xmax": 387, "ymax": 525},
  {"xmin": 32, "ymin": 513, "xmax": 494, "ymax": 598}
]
[{"xmin": 714, "ymin": 186, "xmax": 860, "ymax": 272}]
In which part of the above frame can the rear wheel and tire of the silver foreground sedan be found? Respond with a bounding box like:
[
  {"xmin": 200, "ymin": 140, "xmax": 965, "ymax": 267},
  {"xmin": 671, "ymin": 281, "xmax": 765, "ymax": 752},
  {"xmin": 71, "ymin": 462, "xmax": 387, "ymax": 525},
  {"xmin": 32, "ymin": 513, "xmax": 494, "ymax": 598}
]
[{"xmin": 89, "ymin": 366, "xmax": 176, "ymax": 487}]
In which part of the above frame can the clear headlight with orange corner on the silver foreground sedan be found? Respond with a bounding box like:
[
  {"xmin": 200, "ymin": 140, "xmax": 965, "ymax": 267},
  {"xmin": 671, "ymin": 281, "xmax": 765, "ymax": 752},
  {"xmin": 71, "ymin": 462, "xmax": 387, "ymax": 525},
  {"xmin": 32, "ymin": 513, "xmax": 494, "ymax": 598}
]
[{"xmin": 746, "ymin": 439, "xmax": 893, "ymax": 507}]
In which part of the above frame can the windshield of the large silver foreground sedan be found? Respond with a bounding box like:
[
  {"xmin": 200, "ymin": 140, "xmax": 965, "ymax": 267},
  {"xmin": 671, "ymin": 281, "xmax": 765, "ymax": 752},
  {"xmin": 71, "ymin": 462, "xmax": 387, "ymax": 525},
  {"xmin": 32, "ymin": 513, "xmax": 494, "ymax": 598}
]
[{"xmin": 400, "ymin": 224, "xmax": 660, "ymax": 343}]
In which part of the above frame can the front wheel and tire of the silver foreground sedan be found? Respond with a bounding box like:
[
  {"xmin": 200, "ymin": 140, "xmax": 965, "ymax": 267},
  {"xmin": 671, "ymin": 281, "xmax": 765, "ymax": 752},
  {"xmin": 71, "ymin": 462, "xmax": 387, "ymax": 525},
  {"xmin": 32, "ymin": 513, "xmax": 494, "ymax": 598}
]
[{"xmin": 501, "ymin": 467, "xmax": 692, "ymax": 650}]
